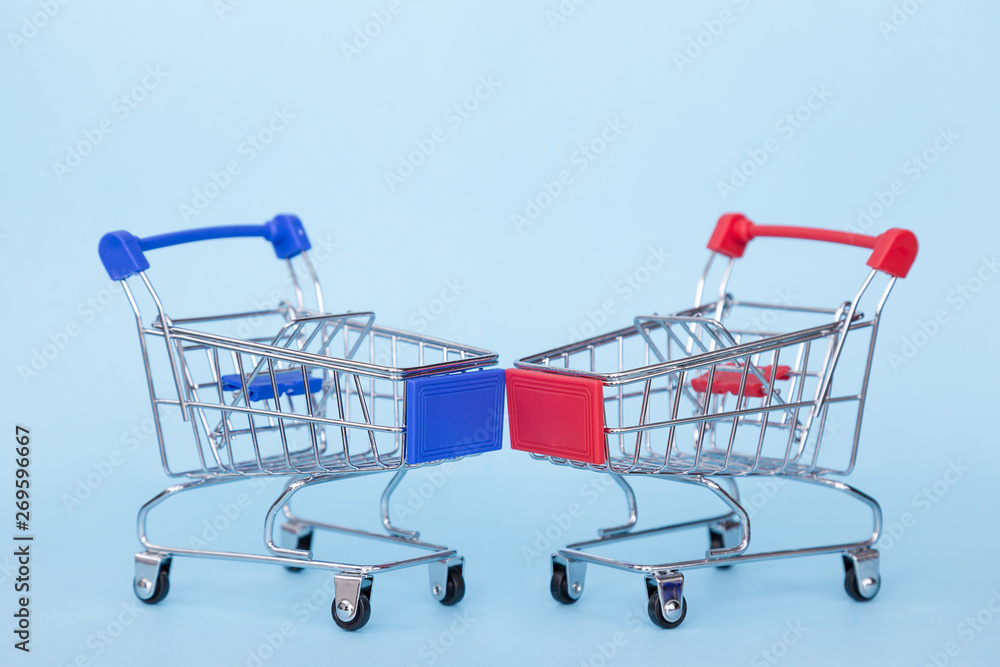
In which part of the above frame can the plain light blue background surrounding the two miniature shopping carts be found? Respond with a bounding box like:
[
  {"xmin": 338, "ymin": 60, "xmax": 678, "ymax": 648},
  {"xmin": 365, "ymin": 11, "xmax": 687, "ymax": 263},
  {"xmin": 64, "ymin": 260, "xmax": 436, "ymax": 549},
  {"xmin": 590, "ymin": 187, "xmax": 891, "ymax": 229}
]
[{"xmin": 0, "ymin": 0, "xmax": 1000, "ymax": 665}]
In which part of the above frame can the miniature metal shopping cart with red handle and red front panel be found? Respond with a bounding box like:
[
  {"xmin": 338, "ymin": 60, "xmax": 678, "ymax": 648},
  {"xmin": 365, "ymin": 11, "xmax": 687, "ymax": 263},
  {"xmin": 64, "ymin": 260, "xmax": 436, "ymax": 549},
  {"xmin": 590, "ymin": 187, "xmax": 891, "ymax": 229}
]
[{"xmin": 507, "ymin": 214, "xmax": 917, "ymax": 628}]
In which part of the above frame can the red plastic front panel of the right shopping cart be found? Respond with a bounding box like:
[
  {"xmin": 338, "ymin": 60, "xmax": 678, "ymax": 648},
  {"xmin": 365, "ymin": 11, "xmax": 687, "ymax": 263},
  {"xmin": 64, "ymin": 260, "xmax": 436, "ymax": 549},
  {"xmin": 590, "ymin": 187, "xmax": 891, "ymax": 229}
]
[{"xmin": 506, "ymin": 368, "xmax": 604, "ymax": 465}]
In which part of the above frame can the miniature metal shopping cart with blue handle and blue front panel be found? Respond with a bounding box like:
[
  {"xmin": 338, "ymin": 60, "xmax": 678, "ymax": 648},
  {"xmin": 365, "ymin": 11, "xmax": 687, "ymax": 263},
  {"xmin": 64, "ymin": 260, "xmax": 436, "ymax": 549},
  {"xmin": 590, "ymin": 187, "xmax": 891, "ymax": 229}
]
[{"xmin": 100, "ymin": 215, "xmax": 504, "ymax": 630}]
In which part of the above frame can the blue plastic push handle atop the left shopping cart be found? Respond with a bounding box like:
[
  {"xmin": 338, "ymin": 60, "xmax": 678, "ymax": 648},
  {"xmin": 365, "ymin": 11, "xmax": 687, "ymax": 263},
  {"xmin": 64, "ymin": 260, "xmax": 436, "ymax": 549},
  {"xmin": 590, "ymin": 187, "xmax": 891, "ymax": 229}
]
[{"xmin": 97, "ymin": 215, "xmax": 312, "ymax": 280}]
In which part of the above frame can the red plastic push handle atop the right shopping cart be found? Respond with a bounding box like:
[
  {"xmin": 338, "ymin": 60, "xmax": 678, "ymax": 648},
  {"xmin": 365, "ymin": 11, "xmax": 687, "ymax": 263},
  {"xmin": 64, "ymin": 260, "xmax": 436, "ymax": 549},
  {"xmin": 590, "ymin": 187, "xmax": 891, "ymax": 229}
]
[{"xmin": 708, "ymin": 213, "xmax": 918, "ymax": 278}]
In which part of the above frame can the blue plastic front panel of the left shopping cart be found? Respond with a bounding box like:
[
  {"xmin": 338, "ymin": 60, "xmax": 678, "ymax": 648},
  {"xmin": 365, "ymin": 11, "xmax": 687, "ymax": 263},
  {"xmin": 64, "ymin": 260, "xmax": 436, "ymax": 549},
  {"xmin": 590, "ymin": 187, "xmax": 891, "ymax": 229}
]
[{"xmin": 406, "ymin": 368, "xmax": 504, "ymax": 464}]
